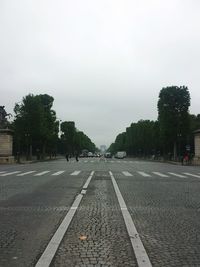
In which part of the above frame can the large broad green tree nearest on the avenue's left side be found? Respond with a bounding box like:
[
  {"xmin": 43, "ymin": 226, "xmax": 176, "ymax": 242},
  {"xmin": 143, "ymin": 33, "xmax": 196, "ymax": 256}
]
[{"xmin": 13, "ymin": 94, "xmax": 59, "ymax": 156}]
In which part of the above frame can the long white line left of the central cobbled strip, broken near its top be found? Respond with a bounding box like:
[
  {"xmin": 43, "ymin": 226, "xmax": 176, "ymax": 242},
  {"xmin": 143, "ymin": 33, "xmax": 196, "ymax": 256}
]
[{"xmin": 35, "ymin": 172, "xmax": 94, "ymax": 267}]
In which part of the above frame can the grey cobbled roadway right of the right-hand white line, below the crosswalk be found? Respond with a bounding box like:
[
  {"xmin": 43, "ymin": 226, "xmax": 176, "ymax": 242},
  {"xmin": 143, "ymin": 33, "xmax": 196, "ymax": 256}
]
[{"xmin": 115, "ymin": 173, "xmax": 200, "ymax": 267}]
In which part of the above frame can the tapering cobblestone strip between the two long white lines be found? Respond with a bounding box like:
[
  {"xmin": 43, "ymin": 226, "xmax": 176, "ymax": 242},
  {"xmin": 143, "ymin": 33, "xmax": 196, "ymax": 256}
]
[{"xmin": 51, "ymin": 172, "xmax": 137, "ymax": 267}]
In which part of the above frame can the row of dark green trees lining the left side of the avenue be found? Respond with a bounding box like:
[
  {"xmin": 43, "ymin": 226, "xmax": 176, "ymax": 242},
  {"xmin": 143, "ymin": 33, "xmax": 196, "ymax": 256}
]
[{"xmin": 10, "ymin": 94, "xmax": 97, "ymax": 159}]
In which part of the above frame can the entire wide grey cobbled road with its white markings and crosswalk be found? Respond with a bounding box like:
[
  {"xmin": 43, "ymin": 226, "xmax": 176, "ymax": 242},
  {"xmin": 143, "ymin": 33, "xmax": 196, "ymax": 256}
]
[{"xmin": 0, "ymin": 158, "xmax": 200, "ymax": 267}]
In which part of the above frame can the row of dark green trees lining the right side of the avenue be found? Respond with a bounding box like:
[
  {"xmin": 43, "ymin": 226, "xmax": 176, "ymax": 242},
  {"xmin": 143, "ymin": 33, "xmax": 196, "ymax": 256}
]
[{"xmin": 109, "ymin": 86, "xmax": 200, "ymax": 159}]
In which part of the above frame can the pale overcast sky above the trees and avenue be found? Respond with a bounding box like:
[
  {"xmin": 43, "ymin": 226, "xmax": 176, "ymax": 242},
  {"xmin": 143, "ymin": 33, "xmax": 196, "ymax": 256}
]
[{"xmin": 0, "ymin": 0, "xmax": 200, "ymax": 146}]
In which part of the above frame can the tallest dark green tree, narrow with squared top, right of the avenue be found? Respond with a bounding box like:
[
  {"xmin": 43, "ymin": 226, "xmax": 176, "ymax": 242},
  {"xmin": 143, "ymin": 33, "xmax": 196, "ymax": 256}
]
[{"xmin": 158, "ymin": 86, "xmax": 190, "ymax": 158}]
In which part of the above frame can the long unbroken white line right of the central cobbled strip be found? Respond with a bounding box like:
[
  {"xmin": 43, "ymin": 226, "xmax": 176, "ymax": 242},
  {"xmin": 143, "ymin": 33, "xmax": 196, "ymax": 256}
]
[{"xmin": 109, "ymin": 171, "xmax": 152, "ymax": 267}]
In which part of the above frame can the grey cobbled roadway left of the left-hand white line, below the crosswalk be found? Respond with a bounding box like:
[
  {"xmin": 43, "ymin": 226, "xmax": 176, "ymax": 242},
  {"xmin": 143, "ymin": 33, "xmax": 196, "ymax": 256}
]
[{"xmin": 0, "ymin": 166, "xmax": 88, "ymax": 267}]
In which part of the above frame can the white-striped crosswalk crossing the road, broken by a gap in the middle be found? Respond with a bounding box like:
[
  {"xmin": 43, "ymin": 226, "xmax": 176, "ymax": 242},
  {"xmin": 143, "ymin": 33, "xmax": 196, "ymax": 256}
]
[{"xmin": 0, "ymin": 170, "xmax": 200, "ymax": 179}]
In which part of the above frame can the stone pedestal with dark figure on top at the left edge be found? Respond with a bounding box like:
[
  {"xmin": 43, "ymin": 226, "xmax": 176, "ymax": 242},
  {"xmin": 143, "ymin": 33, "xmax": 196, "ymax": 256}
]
[{"xmin": 0, "ymin": 106, "xmax": 14, "ymax": 163}]
